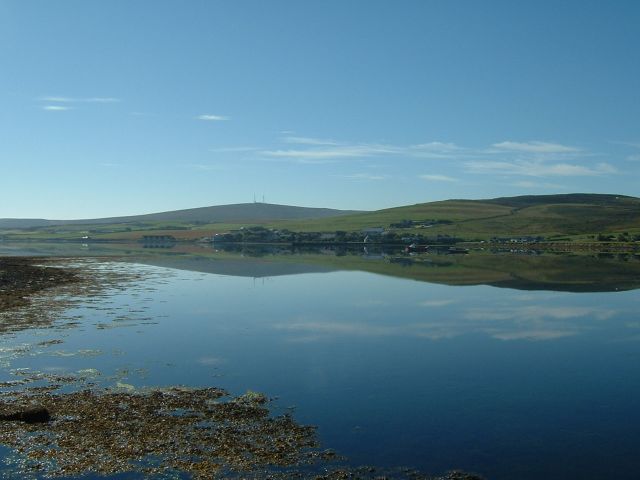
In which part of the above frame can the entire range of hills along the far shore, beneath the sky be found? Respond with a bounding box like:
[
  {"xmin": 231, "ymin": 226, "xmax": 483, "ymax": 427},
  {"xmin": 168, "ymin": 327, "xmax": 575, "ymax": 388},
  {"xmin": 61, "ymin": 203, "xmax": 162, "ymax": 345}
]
[{"xmin": 0, "ymin": 194, "xmax": 640, "ymax": 241}]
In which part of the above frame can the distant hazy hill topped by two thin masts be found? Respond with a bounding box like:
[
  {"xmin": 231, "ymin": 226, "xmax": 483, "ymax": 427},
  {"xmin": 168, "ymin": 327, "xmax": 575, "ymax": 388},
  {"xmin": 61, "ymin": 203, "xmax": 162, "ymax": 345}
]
[{"xmin": 0, "ymin": 203, "xmax": 356, "ymax": 229}]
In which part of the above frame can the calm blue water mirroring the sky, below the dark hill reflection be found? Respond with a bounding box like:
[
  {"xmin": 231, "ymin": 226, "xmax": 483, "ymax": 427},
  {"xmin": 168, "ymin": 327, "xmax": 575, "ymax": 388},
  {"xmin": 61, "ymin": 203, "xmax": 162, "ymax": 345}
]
[{"xmin": 0, "ymin": 246, "xmax": 640, "ymax": 480}]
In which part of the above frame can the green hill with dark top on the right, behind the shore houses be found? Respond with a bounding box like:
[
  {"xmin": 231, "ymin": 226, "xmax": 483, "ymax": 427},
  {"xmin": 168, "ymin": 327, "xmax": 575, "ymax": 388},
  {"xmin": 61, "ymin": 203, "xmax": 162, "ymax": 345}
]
[{"xmin": 272, "ymin": 193, "xmax": 640, "ymax": 240}]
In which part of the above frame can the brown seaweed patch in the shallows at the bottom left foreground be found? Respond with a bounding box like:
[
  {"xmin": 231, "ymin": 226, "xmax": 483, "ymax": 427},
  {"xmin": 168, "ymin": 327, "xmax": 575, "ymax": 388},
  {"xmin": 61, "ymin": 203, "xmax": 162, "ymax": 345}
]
[{"xmin": 0, "ymin": 387, "xmax": 318, "ymax": 478}]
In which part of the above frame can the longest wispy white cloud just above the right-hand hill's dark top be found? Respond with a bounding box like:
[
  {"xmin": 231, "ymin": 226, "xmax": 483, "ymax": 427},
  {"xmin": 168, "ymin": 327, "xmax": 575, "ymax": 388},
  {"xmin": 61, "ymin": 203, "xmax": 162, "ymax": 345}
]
[{"xmin": 465, "ymin": 160, "xmax": 617, "ymax": 177}]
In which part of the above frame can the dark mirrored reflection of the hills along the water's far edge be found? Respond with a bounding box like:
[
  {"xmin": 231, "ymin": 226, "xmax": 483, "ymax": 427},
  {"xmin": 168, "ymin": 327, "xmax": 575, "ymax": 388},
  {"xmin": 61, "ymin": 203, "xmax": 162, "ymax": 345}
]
[{"xmin": 0, "ymin": 243, "xmax": 640, "ymax": 292}]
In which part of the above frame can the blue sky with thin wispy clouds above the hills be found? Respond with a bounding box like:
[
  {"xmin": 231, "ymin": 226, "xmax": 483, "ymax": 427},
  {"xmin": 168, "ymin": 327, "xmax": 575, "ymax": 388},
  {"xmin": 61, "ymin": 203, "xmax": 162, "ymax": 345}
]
[{"xmin": 0, "ymin": 0, "xmax": 640, "ymax": 219}]
